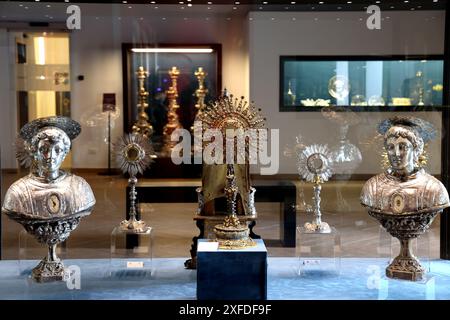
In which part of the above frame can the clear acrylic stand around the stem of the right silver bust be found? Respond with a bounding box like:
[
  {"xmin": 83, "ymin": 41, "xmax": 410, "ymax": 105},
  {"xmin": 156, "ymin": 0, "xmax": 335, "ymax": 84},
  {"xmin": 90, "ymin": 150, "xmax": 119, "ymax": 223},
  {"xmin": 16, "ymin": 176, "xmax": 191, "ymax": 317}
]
[{"xmin": 377, "ymin": 226, "xmax": 431, "ymax": 273}]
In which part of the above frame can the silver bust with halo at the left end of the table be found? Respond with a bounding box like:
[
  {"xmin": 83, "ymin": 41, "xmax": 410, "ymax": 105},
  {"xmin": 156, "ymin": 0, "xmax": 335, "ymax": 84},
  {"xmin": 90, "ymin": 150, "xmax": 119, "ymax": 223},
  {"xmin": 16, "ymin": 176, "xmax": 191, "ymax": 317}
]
[{"xmin": 2, "ymin": 117, "xmax": 95, "ymax": 282}]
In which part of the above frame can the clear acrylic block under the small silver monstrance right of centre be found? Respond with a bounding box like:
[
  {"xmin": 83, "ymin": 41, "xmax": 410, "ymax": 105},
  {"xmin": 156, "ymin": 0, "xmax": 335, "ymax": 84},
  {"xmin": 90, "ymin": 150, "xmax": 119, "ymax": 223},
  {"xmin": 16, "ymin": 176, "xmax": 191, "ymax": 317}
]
[{"xmin": 296, "ymin": 227, "xmax": 341, "ymax": 276}]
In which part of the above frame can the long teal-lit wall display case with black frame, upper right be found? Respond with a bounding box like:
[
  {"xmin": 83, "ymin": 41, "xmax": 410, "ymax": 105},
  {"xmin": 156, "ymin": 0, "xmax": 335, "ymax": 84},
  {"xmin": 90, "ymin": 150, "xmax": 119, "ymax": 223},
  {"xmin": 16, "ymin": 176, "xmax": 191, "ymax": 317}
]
[{"xmin": 280, "ymin": 56, "xmax": 444, "ymax": 111}]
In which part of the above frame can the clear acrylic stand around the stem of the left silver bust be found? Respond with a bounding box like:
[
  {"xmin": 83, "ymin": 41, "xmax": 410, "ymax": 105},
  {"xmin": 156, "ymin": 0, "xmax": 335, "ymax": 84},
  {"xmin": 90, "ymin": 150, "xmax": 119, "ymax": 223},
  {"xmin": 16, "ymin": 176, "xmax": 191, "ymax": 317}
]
[{"xmin": 17, "ymin": 230, "xmax": 67, "ymax": 276}]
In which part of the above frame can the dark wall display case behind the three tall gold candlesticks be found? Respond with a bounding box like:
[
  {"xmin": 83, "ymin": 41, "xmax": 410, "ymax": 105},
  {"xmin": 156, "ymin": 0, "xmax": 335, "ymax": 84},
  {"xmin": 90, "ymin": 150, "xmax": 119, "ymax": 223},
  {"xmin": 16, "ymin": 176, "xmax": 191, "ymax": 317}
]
[{"xmin": 122, "ymin": 44, "xmax": 222, "ymax": 147}]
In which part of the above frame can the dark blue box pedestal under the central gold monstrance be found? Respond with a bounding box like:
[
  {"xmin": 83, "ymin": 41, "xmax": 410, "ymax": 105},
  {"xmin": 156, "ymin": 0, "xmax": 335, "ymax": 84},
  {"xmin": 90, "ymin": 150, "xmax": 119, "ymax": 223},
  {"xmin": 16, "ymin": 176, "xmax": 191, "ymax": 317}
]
[{"xmin": 197, "ymin": 239, "xmax": 267, "ymax": 300}]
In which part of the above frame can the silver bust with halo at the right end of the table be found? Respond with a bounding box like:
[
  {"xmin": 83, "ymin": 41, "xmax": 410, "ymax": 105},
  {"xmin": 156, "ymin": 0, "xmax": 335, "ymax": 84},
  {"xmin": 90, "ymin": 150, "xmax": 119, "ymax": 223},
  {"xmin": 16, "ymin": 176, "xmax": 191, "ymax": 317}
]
[{"xmin": 361, "ymin": 117, "xmax": 450, "ymax": 281}]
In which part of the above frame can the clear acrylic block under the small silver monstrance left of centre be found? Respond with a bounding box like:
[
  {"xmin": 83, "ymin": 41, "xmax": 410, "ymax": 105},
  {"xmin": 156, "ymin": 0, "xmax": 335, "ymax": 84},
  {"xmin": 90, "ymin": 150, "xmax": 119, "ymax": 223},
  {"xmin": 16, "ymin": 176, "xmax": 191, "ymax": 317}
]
[{"xmin": 110, "ymin": 227, "xmax": 153, "ymax": 280}]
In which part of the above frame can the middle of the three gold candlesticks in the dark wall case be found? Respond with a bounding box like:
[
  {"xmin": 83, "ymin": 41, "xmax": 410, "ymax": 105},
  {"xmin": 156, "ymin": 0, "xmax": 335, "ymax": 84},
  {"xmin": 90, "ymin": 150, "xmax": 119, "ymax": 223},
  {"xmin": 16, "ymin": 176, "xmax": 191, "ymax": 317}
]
[{"xmin": 163, "ymin": 67, "xmax": 182, "ymax": 153}]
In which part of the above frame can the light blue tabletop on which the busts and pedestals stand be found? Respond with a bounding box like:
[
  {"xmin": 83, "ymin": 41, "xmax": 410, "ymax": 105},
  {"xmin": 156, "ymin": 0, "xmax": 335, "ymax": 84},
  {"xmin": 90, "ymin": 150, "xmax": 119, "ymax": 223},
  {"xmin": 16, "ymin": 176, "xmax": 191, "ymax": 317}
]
[{"xmin": 0, "ymin": 258, "xmax": 450, "ymax": 300}]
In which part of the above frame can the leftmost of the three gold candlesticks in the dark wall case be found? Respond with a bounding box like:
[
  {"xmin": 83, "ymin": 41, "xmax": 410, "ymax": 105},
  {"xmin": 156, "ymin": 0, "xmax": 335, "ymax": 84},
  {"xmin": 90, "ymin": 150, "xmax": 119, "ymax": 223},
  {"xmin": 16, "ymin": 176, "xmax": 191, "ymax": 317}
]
[{"xmin": 132, "ymin": 67, "xmax": 153, "ymax": 138}]
